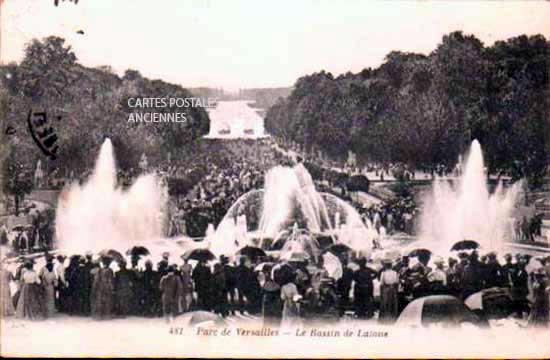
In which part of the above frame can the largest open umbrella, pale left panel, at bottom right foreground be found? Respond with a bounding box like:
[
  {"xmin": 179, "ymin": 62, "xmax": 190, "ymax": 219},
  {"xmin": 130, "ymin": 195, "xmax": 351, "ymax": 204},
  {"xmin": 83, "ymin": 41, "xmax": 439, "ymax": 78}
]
[{"xmin": 396, "ymin": 295, "xmax": 486, "ymax": 327}]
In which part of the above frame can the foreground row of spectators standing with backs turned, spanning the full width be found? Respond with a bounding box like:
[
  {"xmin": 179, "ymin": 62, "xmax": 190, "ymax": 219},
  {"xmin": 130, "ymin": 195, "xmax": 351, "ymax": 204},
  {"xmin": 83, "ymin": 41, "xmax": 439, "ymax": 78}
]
[{"xmin": 1, "ymin": 251, "xmax": 550, "ymax": 327}]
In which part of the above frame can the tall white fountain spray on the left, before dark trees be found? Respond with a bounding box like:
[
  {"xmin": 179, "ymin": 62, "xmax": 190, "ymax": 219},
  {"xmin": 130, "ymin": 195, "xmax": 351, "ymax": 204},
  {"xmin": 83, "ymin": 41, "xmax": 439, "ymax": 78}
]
[{"xmin": 56, "ymin": 139, "xmax": 167, "ymax": 254}]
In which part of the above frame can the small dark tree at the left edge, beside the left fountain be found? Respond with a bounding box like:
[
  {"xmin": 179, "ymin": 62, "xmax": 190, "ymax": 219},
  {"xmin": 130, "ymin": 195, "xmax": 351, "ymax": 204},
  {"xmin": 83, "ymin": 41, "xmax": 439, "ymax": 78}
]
[{"xmin": 2, "ymin": 146, "xmax": 33, "ymax": 216}]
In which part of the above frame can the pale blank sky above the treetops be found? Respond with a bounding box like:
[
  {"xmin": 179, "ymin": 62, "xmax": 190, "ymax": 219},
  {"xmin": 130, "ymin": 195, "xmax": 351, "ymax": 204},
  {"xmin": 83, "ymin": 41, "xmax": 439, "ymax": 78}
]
[{"xmin": 0, "ymin": 0, "xmax": 550, "ymax": 91}]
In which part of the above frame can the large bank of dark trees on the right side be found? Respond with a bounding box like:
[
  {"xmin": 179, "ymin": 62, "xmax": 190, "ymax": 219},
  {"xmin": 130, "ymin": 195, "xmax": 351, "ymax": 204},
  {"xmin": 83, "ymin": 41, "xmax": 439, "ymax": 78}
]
[{"xmin": 266, "ymin": 32, "xmax": 550, "ymax": 186}]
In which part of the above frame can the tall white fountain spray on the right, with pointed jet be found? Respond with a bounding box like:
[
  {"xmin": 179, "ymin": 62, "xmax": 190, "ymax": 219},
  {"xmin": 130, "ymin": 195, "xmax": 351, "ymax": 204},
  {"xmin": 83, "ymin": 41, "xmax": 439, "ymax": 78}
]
[{"xmin": 420, "ymin": 140, "xmax": 521, "ymax": 253}]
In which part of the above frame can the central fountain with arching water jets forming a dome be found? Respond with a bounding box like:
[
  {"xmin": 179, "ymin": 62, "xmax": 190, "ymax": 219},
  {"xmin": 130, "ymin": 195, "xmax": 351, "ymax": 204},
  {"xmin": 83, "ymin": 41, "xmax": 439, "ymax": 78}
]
[{"xmin": 210, "ymin": 164, "xmax": 377, "ymax": 254}]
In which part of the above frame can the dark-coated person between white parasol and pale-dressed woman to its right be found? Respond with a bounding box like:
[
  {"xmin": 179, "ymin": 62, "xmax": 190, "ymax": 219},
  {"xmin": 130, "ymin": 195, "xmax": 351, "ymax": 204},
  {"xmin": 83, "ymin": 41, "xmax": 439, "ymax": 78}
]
[{"xmin": 353, "ymin": 258, "xmax": 378, "ymax": 319}]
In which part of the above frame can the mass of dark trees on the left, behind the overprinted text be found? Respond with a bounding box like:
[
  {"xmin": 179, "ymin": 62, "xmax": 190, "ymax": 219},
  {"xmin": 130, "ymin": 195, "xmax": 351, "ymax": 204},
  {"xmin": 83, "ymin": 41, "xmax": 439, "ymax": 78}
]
[{"xmin": 0, "ymin": 36, "xmax": 209, "ymax": 180}]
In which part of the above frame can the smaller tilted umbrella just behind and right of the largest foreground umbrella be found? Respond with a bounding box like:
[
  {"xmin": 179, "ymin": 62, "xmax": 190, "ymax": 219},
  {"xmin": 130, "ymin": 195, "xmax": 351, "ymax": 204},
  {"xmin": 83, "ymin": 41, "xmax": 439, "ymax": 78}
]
[{"xmin": 464, "ymin": 287, "xmax": 514, "ymax": 319}]
